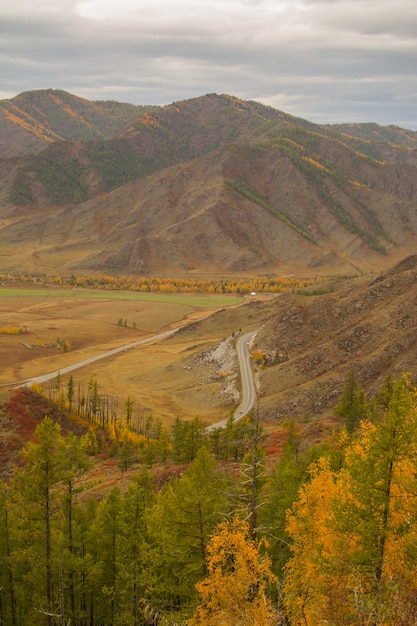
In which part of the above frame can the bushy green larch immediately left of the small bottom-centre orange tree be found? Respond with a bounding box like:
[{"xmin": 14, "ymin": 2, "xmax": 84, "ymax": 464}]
[{"xmin": 148, "ymin": 448, "xmax": 230, "ymax": 611}]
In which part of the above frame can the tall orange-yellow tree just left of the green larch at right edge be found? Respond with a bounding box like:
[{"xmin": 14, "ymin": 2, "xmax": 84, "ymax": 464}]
[{"xmin": 285, "ymin": 459, "xmax": 355, "ymax": 625}]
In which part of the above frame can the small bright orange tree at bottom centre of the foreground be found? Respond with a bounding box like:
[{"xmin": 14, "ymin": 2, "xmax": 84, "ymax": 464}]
[{"xmin": 188, "ymin": 519, "xmax": 279, "ymax": 626}]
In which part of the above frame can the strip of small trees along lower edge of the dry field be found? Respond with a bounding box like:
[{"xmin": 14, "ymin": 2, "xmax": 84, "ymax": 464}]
[{"xmin": 44, "ymin": 374, "xmax": 266, "ymax": 466}]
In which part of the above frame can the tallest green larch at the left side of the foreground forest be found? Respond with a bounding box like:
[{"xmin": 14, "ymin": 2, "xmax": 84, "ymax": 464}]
[{"xmin": 12, "ymin": 417, "xmax": 66, "ymax": 624}]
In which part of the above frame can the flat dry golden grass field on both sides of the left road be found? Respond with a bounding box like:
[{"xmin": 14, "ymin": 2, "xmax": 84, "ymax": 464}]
[{"xmin": 0, "ymin": 287, "xmax": 250, "ymax": 422}]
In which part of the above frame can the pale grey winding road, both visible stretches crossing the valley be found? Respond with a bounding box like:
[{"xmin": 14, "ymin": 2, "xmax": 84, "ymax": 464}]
[{"xmin": 9, "ymin": 329, "xmax": 258, "ymax": 432}]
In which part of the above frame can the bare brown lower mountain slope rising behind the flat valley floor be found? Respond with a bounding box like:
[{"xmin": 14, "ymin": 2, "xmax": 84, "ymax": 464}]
[{"xmin": 0, "ymin": 146, "xmax": 417, "ymax": 275}]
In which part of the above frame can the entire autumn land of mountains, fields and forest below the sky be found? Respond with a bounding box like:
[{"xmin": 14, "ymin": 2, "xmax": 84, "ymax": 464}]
[{"xmin": 0, "ymin": 90, "xmax": 417, "ymax": 626}]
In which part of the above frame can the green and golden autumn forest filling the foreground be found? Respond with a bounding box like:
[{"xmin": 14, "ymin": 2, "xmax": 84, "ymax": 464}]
[{"xmin": 0, "ymin": 372, "xmax": 417, "ymax": 626}]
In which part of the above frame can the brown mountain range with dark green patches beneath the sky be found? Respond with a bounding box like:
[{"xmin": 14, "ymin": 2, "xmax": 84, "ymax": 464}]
[{"xmin": 0, "ymin": 91, "xmax": 417, "ymax": 274}]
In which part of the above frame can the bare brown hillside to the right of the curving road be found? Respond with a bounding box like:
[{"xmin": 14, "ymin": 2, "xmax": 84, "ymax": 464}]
[{"xmin": 256, "ymin": 255, "xmax": 417, "ymax": 421}]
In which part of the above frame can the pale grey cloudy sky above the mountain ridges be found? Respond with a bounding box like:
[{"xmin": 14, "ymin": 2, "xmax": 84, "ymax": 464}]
[{"xmin": 0, "ymin": 0, "xmax": 417, "ymax": 130}]
